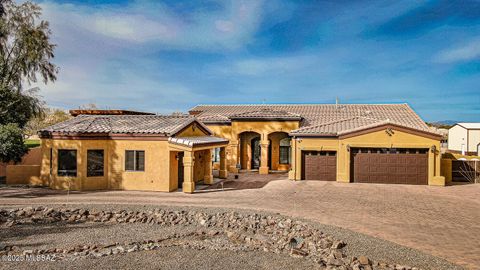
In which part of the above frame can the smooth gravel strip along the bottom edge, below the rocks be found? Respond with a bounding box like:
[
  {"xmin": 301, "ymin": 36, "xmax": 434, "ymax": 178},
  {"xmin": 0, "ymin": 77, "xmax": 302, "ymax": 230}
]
[{"xmin": 0, "ymin": 247, "xmax": 321, "ymax": 270}]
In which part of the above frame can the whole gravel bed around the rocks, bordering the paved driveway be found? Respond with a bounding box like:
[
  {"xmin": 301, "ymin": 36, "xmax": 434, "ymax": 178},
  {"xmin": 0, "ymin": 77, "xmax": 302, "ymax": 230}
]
[{"xmin": 0, "ymin": 205, "xmax": 461, "ymax": 269}]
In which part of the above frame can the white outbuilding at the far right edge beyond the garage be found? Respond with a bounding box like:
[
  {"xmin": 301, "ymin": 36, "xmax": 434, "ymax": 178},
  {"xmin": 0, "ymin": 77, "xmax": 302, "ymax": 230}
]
[{"xmin": 448, "ymin": 123, "xmax": 480, "ymax": 155}]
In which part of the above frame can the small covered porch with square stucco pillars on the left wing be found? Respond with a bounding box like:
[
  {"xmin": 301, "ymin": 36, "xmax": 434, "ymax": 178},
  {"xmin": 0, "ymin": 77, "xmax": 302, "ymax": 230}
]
[{"xmin": 168, "ymin": 136, "xmax": 228, "ymax": 193}]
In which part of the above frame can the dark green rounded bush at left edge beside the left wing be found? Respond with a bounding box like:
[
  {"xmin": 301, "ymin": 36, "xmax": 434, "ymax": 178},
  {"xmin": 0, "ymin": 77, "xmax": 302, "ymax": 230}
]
[{"xmin": 0, "ymin": 124, "xmax": 28, "ymax": 162}]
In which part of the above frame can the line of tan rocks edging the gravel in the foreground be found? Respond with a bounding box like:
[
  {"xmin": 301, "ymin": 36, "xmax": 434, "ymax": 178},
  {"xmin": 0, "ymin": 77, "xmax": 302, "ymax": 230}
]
[{"xmin": 0, "ymin": 206, "xmax": 418, "ymax": 270}]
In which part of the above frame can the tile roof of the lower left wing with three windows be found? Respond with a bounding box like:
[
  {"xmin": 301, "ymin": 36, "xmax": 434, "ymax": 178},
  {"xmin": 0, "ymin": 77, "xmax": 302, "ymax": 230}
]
[{"xmin": 39, "ymin": 115, "xmax": 213, "ymax": 136}]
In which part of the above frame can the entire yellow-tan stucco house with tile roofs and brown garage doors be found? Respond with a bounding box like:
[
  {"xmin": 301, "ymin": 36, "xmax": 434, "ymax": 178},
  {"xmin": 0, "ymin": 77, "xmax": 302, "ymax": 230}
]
[{"xmin": 39, "ymin": 104, "xmax": 445, "ymax": 193}]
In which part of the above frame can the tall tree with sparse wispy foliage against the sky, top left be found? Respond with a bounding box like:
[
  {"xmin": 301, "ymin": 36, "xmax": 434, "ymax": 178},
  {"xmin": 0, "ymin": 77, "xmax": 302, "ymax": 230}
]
[{"xmin": 0, "ymin": 0, "xmax": 58, "ymax": 91}]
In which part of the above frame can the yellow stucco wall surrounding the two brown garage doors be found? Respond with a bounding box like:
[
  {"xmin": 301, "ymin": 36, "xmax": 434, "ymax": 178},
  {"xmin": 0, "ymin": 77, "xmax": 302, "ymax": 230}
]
[{"xmin": 289, "ymin": 129, "xmax": 445, "ymax": 186}]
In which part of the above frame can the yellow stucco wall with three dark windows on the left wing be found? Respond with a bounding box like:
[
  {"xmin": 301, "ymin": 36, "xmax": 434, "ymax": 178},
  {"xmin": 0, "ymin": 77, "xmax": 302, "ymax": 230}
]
[{"xmin": 41, "ymin": 139, "xmax": 170, "ymax": 191}]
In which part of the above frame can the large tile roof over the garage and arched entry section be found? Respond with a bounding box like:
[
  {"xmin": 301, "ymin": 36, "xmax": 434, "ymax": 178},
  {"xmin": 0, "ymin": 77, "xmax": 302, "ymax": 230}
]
[{"xmin": 190, "ymin": 104, "xmax": 429, "ymax": 135}]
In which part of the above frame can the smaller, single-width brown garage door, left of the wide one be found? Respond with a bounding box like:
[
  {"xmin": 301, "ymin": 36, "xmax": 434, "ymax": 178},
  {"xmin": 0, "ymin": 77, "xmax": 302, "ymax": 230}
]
[{"xmin": 302, "ymin": 151, "xmax": 337, "ymax": 181}]
